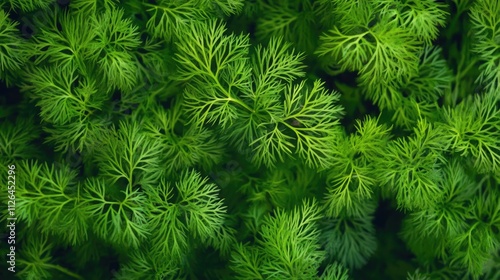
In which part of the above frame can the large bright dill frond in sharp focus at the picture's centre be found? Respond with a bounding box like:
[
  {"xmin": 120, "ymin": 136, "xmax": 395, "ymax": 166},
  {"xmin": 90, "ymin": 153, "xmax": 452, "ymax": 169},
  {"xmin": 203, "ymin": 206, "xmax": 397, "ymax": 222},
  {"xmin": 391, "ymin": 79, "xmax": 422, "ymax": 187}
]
[{"xmin": 176, "ymin": 21, "xmax": 342, "ymax": 168}]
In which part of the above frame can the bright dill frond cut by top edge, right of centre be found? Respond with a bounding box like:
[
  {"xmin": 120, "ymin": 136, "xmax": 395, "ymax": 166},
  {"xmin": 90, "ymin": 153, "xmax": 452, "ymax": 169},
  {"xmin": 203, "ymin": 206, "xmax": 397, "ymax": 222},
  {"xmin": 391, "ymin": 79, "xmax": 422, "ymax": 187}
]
[{"xmin": 316, "ymin": 0, "xmax": 451, "ymax": 128}]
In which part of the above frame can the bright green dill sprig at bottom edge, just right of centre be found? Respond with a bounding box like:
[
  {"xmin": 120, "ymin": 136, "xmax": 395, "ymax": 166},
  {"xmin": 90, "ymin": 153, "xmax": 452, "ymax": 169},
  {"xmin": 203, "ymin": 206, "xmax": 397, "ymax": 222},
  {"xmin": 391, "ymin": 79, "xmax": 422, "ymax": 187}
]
[{"xmin": 231, "ymin": 198, "xmax": 335, "ymax": 279}]
